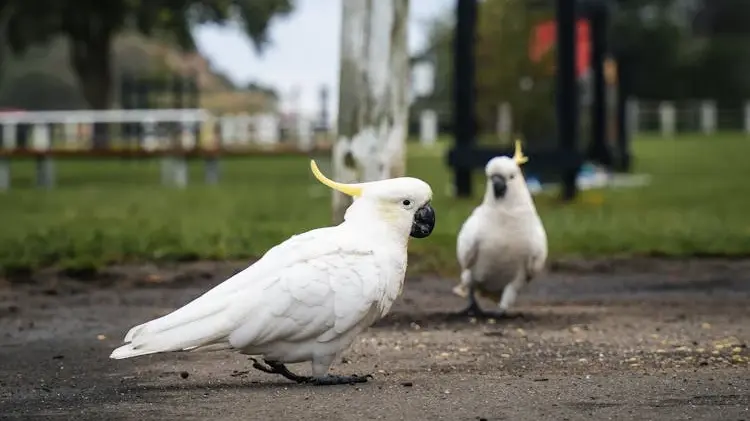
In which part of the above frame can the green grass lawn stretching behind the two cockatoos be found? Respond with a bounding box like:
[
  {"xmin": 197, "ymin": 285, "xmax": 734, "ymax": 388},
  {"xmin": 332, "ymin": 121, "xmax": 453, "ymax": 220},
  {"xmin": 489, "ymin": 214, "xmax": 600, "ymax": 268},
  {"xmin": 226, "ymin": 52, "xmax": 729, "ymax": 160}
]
[{"xmin": 0, "ymin": 135, "xmax": 750, "ymax": 273}]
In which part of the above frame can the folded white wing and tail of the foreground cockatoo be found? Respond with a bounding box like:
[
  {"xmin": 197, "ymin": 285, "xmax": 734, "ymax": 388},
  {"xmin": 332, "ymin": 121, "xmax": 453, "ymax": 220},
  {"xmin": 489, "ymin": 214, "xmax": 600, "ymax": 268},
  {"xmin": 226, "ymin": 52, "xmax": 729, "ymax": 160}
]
[{"xmin": 111, "ymin": 227, "xmax": 387, "ymax": 358}]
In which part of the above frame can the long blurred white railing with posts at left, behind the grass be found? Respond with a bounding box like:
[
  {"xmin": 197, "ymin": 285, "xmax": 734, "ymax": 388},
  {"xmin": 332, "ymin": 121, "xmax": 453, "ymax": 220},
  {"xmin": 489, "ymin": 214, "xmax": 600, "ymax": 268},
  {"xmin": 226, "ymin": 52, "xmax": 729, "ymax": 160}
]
[{"xmin": 0, "ymin": 109, "xmax": 326, "ymax": 190}]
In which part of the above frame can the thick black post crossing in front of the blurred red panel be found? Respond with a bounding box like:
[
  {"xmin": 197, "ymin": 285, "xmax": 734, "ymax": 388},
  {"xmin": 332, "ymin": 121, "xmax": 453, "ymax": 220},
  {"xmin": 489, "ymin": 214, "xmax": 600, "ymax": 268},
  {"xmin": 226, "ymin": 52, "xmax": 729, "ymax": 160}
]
[{"xmin": 560, "ymin": 0, "xmax": 579, "ymax": 200}]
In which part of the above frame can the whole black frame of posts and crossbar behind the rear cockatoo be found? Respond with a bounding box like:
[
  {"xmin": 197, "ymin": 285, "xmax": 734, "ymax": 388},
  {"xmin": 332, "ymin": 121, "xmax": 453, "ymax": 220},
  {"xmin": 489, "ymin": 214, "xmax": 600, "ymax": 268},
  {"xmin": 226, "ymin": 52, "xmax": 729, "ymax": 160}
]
[{"xmin": 447, "ymin": 0, "xmax": 630, "ymax": 200}]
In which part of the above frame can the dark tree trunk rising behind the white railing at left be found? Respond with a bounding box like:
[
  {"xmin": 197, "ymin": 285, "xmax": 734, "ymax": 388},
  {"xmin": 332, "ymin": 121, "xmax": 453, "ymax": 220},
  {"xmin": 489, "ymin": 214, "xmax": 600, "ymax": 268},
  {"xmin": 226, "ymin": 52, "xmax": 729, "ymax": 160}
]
[{"xmin": 70, "ymin": 31, "xmax": 112, "ymax": 149}]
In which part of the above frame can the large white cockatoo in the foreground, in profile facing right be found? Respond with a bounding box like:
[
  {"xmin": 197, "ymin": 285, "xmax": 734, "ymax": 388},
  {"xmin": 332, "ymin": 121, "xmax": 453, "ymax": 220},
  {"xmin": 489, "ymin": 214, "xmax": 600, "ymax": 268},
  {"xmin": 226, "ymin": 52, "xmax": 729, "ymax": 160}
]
[{"xmin": 110, "ymin": 161, "xmax": 435, "ymax": 384}]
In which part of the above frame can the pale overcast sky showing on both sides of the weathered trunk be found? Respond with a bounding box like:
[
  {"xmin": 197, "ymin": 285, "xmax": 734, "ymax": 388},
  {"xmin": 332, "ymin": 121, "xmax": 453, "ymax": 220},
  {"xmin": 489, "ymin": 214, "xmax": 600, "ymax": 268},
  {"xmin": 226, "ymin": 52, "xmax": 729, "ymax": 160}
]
[{"xmin": 195, "ymin": 0, "xmax": 455, "ymax": 115}]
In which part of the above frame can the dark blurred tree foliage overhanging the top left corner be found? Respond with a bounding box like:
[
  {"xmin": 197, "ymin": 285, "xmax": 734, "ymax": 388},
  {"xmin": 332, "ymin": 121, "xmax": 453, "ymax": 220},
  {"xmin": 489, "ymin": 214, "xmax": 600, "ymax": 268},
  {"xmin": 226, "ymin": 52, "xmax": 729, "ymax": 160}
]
[{"xmin": 0, "ymin": 0, "xmax": 293, "ymax": 109}]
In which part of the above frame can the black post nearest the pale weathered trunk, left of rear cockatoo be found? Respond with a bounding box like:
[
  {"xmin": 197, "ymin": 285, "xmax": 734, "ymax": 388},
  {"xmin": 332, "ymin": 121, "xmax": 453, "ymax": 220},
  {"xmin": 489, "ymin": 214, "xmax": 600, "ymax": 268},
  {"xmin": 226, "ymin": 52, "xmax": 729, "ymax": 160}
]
[{"xmin": 453, "ymin": 0, "xmax": 477, "ymax": 197}]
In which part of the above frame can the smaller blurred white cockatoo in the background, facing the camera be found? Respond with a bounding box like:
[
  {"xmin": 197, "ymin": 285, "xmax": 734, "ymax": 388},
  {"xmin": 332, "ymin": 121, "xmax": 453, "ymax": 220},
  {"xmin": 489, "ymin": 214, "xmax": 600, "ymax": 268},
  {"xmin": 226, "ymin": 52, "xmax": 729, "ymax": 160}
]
[{"xmin": 453, "ymin": 142, "xmax": 547, "ymax": 317}]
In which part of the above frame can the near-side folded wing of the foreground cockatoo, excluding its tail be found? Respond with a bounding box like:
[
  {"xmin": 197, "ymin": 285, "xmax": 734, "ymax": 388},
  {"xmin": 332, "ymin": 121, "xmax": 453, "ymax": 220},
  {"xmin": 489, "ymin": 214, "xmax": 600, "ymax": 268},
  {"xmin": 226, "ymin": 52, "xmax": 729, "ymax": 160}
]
[{"xmin": 229, "ymin": 252, "xmax": 385, "ymax": 348}]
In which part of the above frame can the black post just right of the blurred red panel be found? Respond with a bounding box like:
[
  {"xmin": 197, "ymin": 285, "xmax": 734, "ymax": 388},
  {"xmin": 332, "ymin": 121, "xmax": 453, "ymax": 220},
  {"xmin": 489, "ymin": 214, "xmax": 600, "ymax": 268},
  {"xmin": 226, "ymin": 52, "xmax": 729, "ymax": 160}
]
[{"xmin": 588, "ymin": 2, "xmax": 612, "ymax": 167}]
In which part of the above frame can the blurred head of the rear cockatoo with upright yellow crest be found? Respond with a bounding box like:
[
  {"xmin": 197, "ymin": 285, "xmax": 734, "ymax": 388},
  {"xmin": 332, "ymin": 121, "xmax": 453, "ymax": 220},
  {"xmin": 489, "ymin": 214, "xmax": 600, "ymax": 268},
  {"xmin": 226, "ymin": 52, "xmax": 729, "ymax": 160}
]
[{"xmin": 484, "ymin": 141, "xmax": 528, "ymax": 201}]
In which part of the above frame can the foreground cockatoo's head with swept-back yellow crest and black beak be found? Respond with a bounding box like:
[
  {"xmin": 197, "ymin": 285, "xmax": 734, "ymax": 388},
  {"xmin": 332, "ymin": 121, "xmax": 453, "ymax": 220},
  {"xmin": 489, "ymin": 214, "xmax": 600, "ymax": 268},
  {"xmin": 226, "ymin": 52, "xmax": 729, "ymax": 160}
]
[{"xmin": 310, "ymin": 161, "xmax": 435, "ymax": 238}]
